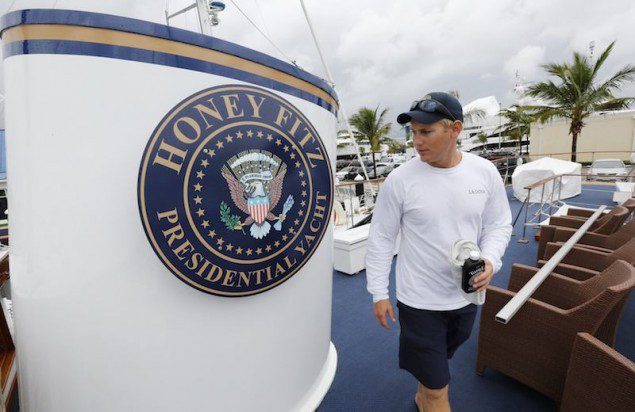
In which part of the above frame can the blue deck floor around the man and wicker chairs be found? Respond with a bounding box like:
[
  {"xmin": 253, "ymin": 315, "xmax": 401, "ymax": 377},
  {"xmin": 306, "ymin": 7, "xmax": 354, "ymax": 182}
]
[{"xmin": 319, "ymin": 185, "xmax": 635, "ymax": 412}]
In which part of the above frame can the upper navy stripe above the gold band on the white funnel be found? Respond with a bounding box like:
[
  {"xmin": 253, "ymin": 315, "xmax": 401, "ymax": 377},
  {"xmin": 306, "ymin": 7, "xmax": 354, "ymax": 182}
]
[{"xmin": 0, "ymin": 9, "xmax": 338, "ymax": 102}]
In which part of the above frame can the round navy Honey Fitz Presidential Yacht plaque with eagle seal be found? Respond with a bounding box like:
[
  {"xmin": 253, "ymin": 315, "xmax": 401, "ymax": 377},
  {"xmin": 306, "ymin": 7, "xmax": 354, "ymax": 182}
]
[{"xmin": 138, "ymin": 85, "xmax": 333, "ymax": 297}]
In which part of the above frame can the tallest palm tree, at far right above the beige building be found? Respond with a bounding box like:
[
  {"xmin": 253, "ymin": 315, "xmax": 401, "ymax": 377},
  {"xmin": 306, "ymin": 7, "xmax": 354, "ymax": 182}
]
[{"xmin": 527, "ymin": 42, "xmax": 635, "ymax": 162}]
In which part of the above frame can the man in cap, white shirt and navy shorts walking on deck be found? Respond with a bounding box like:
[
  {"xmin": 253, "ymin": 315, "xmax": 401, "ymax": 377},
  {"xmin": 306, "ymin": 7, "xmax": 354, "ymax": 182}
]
[{"xmin": 366, "ymin": 92, "xmax": 512, "ymax": 412}]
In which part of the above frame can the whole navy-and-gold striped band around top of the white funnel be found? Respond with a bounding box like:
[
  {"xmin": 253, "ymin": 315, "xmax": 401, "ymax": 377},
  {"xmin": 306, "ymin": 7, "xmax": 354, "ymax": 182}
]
[{"xmin": 0, "ymin": 9, "xmax": 338, "ymax": 115}]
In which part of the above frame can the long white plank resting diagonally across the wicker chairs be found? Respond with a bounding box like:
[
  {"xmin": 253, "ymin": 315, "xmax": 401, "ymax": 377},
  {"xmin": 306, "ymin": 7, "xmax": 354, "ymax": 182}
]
[{"xmin": 495, "ymin": 205, "xmax": 606, "ymax": 324}]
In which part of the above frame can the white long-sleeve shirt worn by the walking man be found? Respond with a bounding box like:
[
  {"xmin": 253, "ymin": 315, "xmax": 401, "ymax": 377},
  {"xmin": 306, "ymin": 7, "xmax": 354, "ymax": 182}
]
[{"xmin": 366, "ymin": 153, "xmax": 512, "ymax": 310}]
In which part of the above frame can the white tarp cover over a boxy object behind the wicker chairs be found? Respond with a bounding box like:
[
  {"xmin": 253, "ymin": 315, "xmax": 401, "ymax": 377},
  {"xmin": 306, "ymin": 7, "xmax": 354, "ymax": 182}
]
[{"xmin": 512, "ymin": 157, "xmax": 582, "ymax": 203}]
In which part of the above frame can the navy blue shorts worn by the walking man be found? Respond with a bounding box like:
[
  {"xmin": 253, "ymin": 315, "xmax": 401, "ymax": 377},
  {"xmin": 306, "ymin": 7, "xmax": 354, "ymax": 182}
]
[{"xmin": 397, "ymin": 302, "xmax": 476, "ymax": 389}]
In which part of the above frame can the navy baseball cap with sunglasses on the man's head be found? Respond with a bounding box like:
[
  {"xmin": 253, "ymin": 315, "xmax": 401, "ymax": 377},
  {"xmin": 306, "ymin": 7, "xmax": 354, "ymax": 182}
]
[{"xmin": 397, "ymin": 92, "xmax": 463, "ymax": 124}]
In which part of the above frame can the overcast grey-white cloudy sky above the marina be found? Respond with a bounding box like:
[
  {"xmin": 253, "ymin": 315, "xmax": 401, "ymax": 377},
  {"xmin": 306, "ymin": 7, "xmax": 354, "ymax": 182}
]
[{"xmin": 0, "ymin": 0, "xmax": 635, "ymax": 137}]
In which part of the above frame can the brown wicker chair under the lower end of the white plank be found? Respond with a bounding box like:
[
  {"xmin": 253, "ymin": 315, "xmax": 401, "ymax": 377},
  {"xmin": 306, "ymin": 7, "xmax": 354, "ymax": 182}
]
[{"xmin": 476, "ymin": 261, "xmax": 635, "ymax": 402}]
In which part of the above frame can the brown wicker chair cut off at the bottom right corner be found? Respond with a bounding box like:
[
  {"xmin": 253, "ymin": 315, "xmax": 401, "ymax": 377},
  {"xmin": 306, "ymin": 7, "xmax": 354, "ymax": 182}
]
[{"xmin": 560, "ymin": 333, "xmax": 635, "ymax": 412}]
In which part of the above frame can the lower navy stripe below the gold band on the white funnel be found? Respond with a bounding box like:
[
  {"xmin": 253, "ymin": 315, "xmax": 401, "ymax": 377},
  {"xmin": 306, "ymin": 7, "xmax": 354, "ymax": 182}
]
[{"xmin": 4, "ymin": 40, "xmax": 337, "ymax": 115}]
